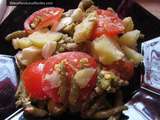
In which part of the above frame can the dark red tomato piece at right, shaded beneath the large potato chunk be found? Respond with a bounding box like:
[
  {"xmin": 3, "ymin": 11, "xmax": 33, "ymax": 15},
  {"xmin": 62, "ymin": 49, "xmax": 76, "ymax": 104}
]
[{"xmin": 107, "ymin": 60, "xmax": 134, "ymax": 80}]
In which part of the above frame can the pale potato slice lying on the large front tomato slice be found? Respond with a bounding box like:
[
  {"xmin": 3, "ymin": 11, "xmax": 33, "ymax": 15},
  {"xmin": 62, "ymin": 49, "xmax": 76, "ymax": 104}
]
[{"xmin": 74, "ymin": 68, "xmax": 96, "ymax": 88}]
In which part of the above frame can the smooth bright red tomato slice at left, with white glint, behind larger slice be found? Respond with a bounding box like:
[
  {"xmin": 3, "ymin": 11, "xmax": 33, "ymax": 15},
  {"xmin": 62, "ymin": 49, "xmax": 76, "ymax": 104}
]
[{"xmin": 22, "ymin": 61, "xmax": 46, "ymax": 100}]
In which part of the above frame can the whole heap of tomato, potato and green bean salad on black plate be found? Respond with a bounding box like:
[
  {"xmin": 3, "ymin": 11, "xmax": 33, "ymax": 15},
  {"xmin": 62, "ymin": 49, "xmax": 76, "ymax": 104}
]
[{"xmin": 6, "ymin": 0, "xmax": 143, "ymax": 119}]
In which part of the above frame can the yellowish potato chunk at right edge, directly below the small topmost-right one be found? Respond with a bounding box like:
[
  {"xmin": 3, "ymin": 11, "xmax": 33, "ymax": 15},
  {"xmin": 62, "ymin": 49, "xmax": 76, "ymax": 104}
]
[{"xmin": 119, "ymin": 30, "xmax": 140, "ymax": 48}]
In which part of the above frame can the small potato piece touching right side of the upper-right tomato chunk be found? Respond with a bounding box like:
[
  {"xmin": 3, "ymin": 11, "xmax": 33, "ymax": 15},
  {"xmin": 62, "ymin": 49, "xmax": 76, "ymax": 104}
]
[{"xmin": 122, "ymin": 17, "xmax": 134, "ymax": 32}]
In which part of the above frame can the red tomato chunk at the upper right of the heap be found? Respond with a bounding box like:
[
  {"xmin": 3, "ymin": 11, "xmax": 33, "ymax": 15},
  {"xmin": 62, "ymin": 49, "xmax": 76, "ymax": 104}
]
[{"xmin": 92, "ymin": 9, "xmax": 124, "ymax": 39}]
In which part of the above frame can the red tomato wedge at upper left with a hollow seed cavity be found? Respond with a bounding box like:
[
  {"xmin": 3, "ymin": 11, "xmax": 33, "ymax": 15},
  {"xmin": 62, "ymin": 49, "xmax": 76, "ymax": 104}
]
[{"xmin": 24, "ymin": 7, "xmax": 64, "ymax": 32}]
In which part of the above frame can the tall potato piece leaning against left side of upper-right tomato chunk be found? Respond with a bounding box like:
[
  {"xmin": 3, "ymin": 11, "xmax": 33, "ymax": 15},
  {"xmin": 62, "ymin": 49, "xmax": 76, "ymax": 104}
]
[{"xmin": 73, "ymin": 12, "xmax": 96, "ymax": 43}]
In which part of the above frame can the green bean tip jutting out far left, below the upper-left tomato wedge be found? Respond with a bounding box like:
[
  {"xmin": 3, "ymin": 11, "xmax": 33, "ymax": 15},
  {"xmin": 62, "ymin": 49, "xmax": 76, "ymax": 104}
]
[{"xmin": 5, "ymin": 30, "xmax": 28, "ymax": 41}]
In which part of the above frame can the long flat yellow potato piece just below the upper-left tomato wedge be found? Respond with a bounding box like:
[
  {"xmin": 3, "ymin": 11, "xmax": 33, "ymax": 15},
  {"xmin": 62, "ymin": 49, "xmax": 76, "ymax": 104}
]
[{"xmin": 29, "ymin": 31, "xmax": 62, "ymax": 48}]
